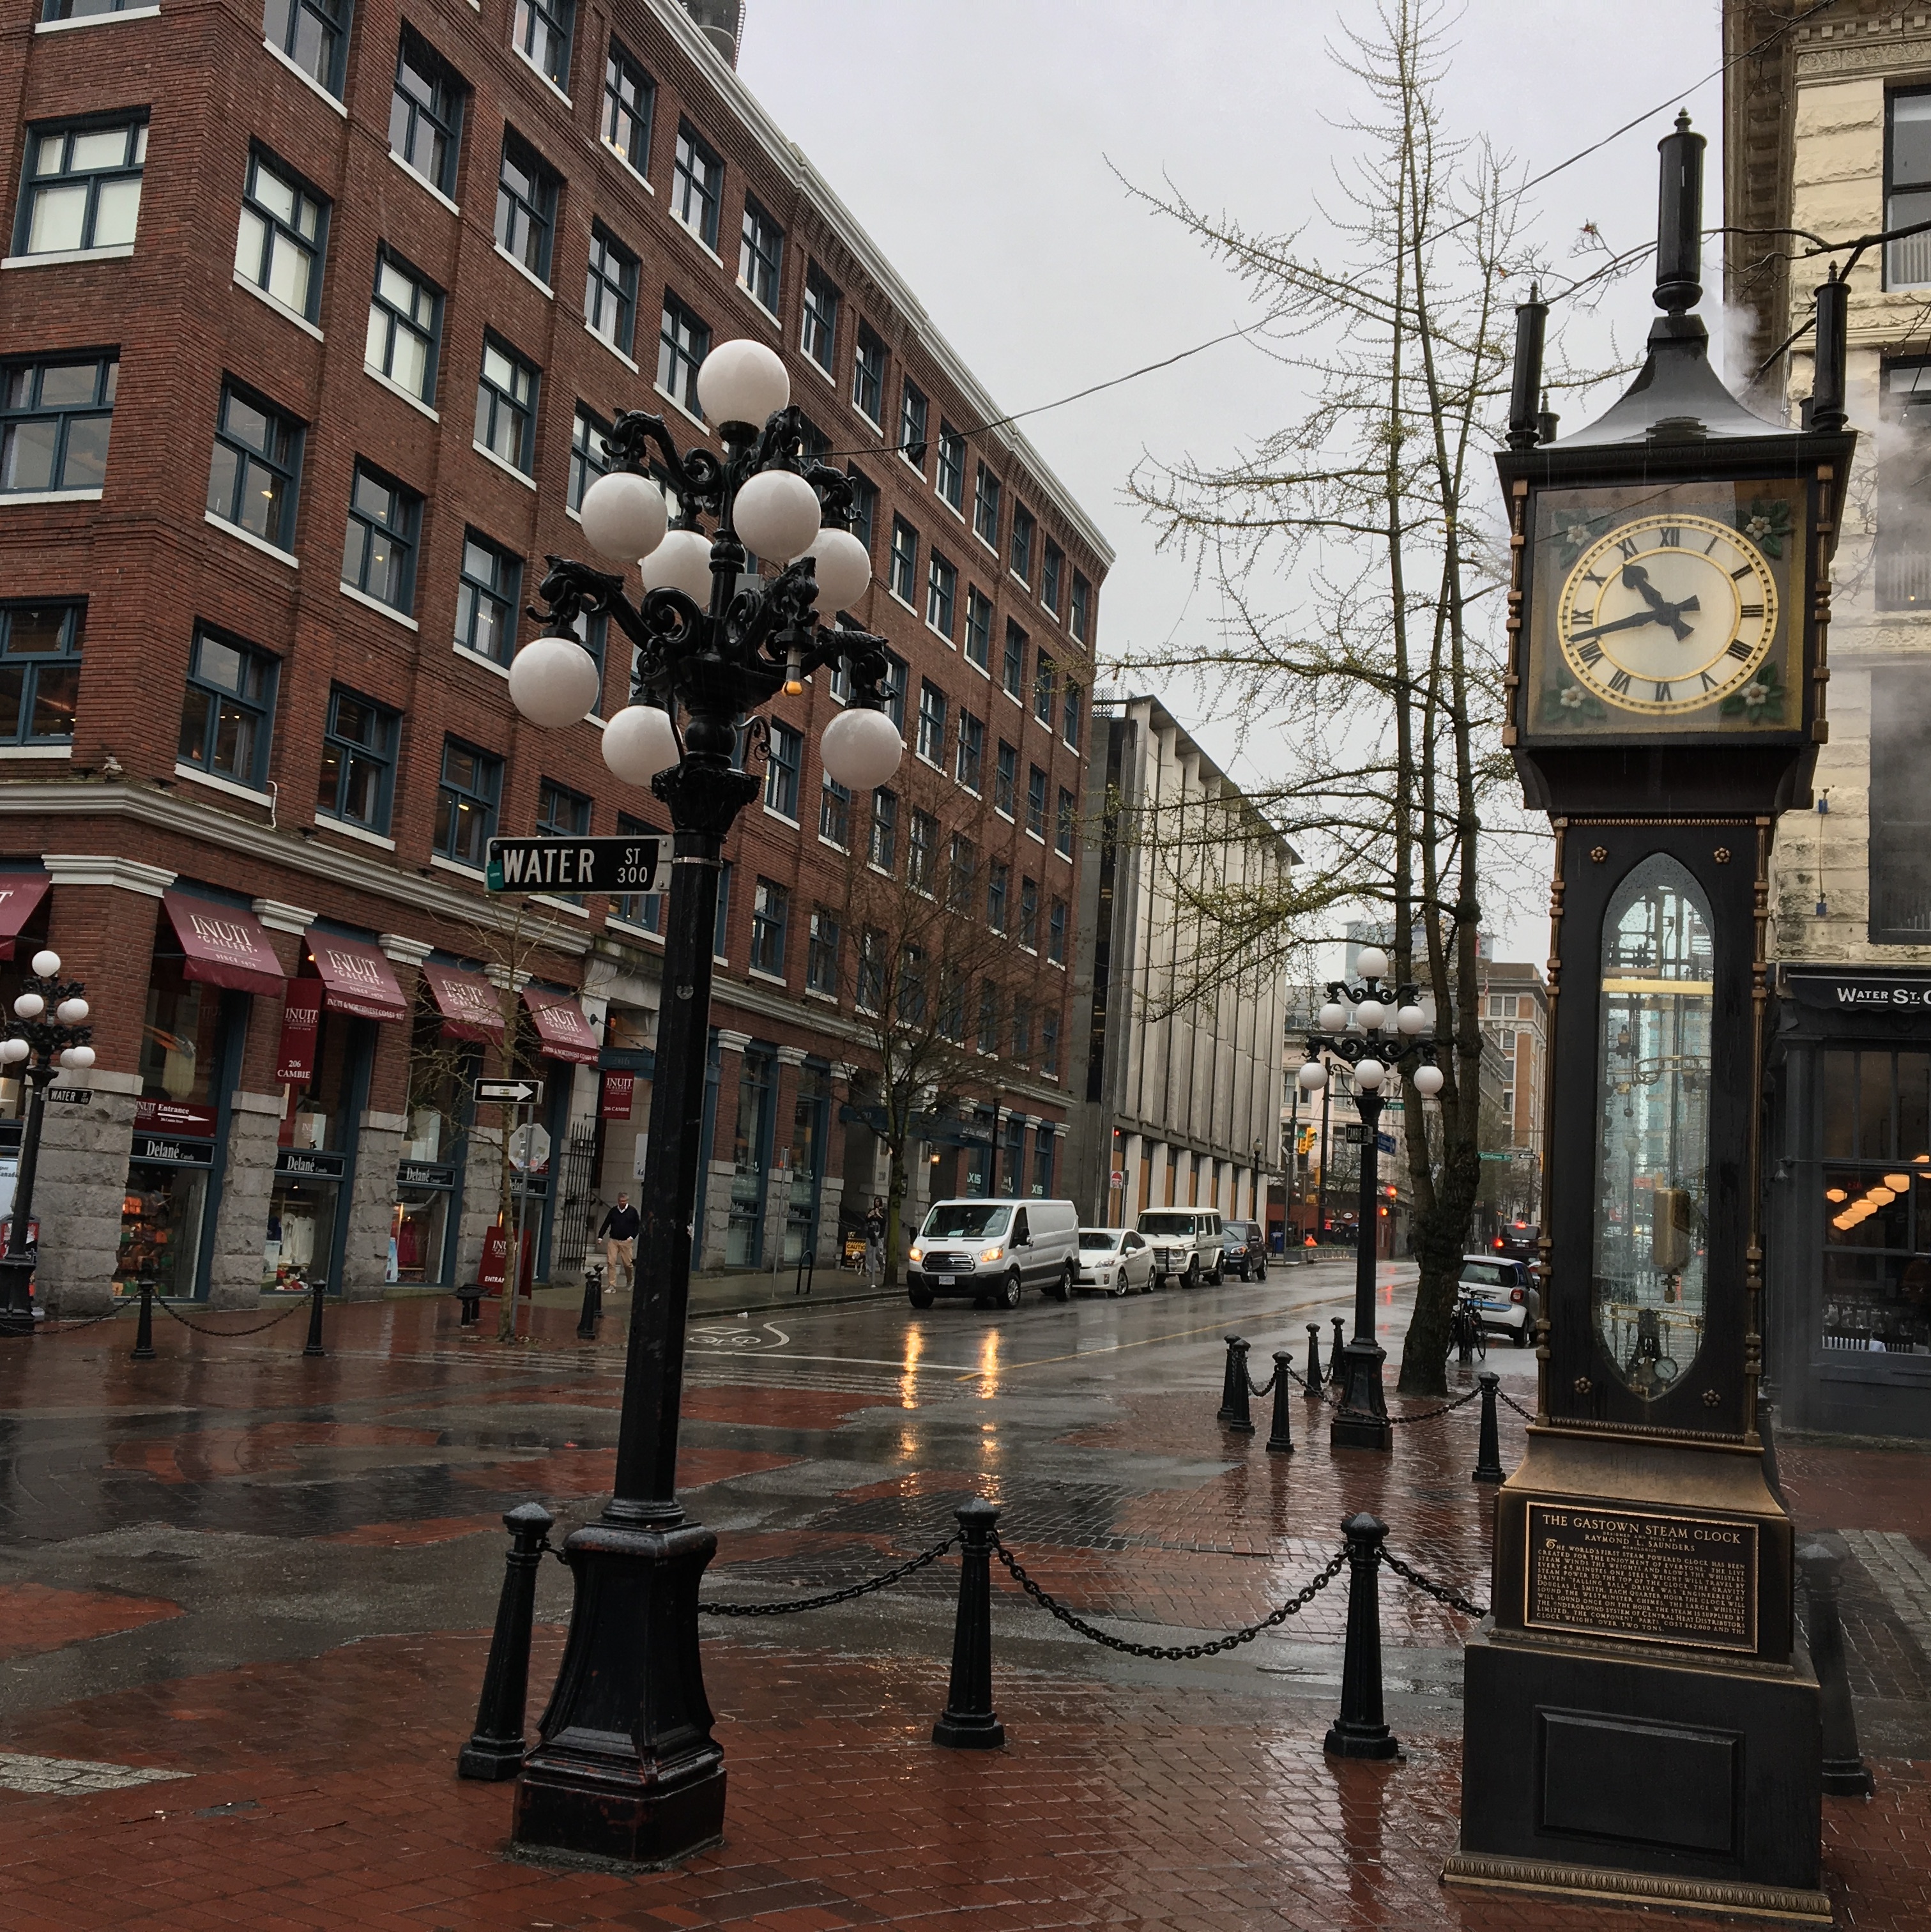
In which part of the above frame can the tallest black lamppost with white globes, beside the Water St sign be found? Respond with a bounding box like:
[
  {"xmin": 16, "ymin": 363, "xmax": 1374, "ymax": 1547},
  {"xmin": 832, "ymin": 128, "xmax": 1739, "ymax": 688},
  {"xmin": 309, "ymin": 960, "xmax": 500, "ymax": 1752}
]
[{"xmin": 490, "ymin": 342, "xmax": 904, "ymax": 1864}]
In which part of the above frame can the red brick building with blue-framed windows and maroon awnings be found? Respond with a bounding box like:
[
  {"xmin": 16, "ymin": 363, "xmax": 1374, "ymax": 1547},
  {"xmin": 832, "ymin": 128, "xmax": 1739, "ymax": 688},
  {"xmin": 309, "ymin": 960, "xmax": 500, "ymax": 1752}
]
[{"xmin": 0, "ymin": 0, "xmax": 1110, "ymax": 1308}]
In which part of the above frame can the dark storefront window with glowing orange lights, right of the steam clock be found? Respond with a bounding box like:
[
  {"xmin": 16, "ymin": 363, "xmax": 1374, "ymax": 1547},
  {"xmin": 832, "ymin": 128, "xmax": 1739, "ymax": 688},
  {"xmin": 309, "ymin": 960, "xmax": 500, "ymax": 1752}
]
[{"xmin": 1819, "ymin": 1051, "xmax": 1931, "ymax": 1354}]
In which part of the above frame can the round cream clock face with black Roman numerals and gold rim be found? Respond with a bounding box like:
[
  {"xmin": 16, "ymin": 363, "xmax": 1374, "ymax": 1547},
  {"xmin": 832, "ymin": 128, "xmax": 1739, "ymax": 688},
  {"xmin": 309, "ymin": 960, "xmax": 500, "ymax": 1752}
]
[{"xmin": 1555, "ymin": 510, "xmax": 1778, "ymax": 717}]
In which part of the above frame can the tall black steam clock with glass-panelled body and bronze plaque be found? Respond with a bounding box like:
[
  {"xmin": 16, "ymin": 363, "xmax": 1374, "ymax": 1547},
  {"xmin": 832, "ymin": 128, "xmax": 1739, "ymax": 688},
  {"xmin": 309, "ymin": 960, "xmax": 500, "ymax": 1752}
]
[{"xmin": 1444, "ymin": 116, "xmax": 1854, "ymax": 1920}]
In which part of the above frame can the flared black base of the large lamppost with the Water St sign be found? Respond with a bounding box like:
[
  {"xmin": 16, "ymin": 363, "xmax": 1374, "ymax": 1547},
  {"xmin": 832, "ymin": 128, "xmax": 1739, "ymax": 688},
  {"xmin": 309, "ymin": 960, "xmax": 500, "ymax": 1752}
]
[{"xmin": 510, "ymin": 1519, "xmax": 724, "ymax": 1870}]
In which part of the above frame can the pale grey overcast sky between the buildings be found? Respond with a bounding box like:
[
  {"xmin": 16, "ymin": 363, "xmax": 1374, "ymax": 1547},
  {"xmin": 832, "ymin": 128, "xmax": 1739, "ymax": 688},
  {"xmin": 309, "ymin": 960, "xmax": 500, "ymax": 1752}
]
[{"xmin": 740, "ymin": 0, "xmax": 1723, "ymax": 960}]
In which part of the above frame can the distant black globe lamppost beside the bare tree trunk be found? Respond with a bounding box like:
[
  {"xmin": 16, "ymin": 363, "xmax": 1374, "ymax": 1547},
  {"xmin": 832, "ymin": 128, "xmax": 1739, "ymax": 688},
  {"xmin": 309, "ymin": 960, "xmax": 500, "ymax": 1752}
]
[{"xmin": 1295, "ymin": 947, "xmax": 1442, "ymax": 1449}]
